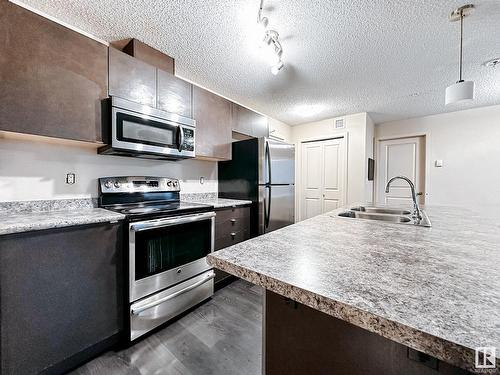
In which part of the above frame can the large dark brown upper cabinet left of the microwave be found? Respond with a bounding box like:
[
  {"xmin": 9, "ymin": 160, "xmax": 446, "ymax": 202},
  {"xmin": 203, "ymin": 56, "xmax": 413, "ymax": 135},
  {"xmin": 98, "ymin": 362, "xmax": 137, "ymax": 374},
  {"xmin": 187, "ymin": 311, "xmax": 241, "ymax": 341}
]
[{"xmin": 0, "ymin": 0, "xmax": 108, "ymax": 142}]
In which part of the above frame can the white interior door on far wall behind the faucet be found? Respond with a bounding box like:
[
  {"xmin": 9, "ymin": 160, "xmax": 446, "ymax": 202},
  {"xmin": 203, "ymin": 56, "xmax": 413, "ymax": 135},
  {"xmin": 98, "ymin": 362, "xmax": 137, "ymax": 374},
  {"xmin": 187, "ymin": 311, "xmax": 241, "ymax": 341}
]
[{"xmin": 376, "ymin": 137, "xmax": 425, "ymax": 205}]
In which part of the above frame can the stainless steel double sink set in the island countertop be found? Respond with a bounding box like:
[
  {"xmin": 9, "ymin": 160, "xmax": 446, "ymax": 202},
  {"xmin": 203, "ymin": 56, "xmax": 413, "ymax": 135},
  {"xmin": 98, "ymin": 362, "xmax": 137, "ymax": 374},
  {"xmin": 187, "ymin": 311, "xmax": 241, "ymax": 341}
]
[{"xmin": 337, "ymin": 206, "xmax": 431, "ymax": 227}]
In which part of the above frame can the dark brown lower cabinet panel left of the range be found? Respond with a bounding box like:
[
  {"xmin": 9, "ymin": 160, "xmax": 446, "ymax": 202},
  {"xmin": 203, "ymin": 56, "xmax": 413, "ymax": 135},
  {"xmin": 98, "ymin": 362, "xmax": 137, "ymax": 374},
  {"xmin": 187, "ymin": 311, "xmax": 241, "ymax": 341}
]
[{"xmin": 0, "ymin": 223, "xmax": 123, "ymax": 375}]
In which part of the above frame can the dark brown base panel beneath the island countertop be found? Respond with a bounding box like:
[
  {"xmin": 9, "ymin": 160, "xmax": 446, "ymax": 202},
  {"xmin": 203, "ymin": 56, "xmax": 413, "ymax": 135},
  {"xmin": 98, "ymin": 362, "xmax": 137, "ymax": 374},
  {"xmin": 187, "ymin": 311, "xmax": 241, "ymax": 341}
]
[{"xmin": 264, "ymin": 291, "xmax": 469, "ymax": 375}]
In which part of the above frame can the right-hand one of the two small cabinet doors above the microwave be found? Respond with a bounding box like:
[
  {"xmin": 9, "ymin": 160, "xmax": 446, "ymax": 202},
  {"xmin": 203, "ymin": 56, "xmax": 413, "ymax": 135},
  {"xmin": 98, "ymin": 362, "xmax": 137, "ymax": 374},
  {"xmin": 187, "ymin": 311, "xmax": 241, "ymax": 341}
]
[{"xmin": 157, "ymin": 69, "xmax": 193, "ymax": 117}]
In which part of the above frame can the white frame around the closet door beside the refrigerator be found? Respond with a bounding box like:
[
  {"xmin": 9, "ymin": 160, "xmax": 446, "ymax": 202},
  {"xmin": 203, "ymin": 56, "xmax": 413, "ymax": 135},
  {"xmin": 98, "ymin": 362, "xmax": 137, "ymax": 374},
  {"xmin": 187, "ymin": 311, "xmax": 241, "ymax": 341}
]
[{"xmin": 295, "ymin": 131, "xmax": 349, "ymax": 222}]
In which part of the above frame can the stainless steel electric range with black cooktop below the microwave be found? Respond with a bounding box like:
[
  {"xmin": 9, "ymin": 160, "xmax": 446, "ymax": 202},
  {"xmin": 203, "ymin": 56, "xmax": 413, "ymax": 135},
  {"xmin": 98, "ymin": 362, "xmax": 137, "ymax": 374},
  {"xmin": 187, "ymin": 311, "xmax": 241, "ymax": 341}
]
[{"xmin": 99, "ymin": 177, "xmax": 215, "ymax": 341}]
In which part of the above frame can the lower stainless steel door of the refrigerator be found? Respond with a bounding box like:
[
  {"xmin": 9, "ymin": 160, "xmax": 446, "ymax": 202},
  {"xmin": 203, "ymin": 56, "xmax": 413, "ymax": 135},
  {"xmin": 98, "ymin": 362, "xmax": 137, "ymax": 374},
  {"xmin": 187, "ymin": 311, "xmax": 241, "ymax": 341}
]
[{"xmin": 259, "ymin": 185, "xmax": 295, "ymax": 234}]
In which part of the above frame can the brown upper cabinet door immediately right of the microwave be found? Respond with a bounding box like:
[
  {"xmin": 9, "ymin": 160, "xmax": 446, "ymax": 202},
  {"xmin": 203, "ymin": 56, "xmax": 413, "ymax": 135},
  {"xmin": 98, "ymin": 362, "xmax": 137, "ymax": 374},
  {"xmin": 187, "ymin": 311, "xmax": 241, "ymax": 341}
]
[{"xmin": 193, "ymin": 86, "xmax": 232, "ymax": 160}]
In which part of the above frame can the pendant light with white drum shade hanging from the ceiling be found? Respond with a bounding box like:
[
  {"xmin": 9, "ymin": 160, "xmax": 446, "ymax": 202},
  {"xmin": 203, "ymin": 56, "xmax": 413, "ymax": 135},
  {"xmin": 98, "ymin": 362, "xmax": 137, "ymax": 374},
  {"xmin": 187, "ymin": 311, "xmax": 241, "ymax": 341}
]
[{"xmin": 445, "ymin": 4, "xmax": 474, "ymax": 105}]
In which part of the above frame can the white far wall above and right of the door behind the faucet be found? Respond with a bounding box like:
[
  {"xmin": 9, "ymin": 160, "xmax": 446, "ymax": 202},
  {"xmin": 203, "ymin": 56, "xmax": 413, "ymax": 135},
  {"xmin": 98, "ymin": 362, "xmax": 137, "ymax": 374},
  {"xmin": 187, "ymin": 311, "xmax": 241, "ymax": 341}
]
[{"xmin": 375, "ymin": 105, "xmax": 500, "ymax": 207}]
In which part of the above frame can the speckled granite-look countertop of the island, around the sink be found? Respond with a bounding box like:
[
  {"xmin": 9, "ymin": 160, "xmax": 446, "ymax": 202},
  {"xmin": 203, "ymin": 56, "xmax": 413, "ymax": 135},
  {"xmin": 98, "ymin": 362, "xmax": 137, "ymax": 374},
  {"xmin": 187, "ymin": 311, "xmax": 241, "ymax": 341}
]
[{"xmin": 208, "ymin": 207, "xmax": 500, "ymax": 371}]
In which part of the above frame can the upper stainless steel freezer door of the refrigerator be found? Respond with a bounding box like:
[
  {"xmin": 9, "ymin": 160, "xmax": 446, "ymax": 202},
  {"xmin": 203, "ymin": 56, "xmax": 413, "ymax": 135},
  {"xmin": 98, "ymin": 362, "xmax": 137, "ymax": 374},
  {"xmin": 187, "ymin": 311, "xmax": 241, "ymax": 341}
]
[{"xmin": 259, "ymin": 138, "xmax": 295, "ymax": 185}]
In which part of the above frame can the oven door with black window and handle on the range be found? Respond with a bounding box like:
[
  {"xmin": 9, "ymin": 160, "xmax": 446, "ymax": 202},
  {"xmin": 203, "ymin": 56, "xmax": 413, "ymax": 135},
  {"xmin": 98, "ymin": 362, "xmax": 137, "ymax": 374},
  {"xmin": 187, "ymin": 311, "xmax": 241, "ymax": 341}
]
[{"xmin": 129, "ymin": 212, "xmax": 215, "ymax": 302}]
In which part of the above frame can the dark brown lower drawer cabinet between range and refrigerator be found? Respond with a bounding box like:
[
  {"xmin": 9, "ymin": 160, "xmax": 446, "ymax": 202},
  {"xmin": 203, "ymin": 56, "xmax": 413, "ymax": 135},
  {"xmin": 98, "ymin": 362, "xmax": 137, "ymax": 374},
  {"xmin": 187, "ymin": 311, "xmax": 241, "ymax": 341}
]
[{"xmin": 215, "ymin": 207, "xmax": 250, "ymax": 289}]
